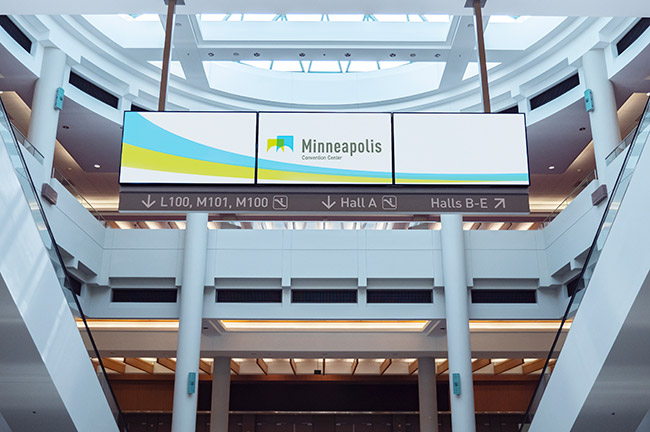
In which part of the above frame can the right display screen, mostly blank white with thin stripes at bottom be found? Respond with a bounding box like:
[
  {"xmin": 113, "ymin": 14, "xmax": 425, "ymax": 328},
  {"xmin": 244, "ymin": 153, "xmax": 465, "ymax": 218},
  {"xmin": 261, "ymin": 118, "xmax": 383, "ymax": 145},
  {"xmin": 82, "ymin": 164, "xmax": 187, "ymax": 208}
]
[{"xmin": 393, "ymin": 113, "xmax": 529, "ymax": 186}]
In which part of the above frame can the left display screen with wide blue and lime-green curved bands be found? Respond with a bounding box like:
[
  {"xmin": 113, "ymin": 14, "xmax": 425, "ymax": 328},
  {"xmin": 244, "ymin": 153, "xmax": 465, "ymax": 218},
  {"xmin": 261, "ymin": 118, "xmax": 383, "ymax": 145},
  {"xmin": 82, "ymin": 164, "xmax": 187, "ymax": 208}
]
[{"xmin": 120, "ymin": 112, "xmax": 257, "ymax": 184}]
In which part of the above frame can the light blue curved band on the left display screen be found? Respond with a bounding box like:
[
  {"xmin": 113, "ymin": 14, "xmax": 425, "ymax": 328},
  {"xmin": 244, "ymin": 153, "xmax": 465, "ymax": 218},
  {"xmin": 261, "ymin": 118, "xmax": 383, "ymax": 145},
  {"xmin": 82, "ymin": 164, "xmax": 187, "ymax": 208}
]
[{"xmin": 123, "ymin": 112, "xmax": 255, "ymax": 168}]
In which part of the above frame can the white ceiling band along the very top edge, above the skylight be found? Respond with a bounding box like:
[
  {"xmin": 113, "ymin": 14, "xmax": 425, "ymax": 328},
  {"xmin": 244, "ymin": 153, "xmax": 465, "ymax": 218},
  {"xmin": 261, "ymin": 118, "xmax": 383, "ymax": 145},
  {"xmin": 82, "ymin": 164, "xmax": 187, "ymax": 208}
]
[{"xmin": 0, "ymin": 0, "xmax": 650, "ymax": 17}]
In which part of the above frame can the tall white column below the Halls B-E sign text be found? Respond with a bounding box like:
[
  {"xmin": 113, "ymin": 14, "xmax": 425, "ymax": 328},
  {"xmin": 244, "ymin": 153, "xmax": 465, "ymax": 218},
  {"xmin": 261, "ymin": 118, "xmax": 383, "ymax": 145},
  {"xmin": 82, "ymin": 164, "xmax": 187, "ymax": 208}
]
[{"xmin": 440, "ymin": 214, "xmax": 476, "ymax": 432}]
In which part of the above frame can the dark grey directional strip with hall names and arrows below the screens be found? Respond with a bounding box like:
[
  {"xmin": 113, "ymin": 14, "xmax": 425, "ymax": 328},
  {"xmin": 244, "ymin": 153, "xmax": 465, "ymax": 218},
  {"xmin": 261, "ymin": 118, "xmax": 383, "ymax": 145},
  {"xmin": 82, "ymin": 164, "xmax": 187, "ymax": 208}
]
[{"xmin": 120, "ymin": 191, "xmax": 529, "ymax": 214}]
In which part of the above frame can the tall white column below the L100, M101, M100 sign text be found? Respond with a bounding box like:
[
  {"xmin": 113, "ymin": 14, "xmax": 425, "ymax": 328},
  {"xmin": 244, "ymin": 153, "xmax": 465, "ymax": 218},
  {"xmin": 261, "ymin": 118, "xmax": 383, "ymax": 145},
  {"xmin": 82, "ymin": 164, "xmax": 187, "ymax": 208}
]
[{"xmin": 172, "ymin": 213, "xmax": 208, "ymax": 432}]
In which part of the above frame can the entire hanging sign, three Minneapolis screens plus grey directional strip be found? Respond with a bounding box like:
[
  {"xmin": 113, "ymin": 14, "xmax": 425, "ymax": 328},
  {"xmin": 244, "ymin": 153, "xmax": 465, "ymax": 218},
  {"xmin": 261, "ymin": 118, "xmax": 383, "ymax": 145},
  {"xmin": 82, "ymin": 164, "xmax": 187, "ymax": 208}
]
[{"xmin": 120, "ymin": 112, "xmax": 529, "ymax": 214}]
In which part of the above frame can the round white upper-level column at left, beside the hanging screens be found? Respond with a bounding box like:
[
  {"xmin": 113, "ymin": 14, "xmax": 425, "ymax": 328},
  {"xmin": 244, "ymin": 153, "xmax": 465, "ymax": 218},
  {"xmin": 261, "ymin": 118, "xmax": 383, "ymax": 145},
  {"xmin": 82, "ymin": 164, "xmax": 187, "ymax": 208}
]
[{"xmin": 27, "ymin": 48, "xmax": 66, "ymax": 177}]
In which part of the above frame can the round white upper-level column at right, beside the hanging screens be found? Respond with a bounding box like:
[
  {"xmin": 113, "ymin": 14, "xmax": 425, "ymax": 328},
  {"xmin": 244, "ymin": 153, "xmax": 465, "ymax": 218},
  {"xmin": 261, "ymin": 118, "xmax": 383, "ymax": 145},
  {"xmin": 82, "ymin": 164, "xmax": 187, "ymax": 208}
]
[{"xmin": 582, "ymin": 49, "xmax": 621, "ymax": 190}]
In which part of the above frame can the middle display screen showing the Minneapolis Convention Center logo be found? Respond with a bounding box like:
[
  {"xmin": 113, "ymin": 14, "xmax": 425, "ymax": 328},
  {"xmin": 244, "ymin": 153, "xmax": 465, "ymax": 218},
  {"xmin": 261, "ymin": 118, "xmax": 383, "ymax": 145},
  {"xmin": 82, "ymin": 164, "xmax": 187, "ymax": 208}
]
[{"xmin": 257, "ymin": 113, "xmax": 392, "ymax": 184}]
